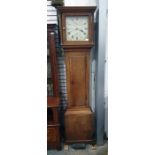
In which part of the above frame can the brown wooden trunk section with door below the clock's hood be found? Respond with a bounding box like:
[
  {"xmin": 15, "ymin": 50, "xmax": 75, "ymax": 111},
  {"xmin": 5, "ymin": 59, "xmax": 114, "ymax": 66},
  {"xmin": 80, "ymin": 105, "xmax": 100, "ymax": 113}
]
[{"xmin": 65, "ymin": 49, "xmax": 89, "ymax": 108}]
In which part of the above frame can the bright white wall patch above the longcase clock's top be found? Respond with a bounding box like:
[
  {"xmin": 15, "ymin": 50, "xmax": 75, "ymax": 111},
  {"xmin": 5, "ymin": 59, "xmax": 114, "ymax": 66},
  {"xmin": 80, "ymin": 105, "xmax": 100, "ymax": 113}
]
[{"xmin": 64, "ymin": 0, "xmax": 97, "ymax": 6}]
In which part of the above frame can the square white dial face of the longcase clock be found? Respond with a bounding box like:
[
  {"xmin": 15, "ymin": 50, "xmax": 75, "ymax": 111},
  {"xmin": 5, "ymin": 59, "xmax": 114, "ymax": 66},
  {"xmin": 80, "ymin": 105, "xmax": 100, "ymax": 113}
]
[{"xmin": 66, "ymin": 16, "xmax": 89, "ymax": 41}]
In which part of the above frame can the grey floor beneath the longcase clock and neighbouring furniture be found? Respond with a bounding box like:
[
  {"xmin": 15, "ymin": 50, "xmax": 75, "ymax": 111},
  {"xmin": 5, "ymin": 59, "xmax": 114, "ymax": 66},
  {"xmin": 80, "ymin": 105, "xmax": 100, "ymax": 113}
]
[{"xmin": 47, "ymin": 144, "xmax": 108, "ymax": 155}]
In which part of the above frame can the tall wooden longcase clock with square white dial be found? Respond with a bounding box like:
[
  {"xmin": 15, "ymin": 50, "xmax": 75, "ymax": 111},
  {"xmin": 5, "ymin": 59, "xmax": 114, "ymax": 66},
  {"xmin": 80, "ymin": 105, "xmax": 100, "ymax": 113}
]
[{"xmin": 58, "ymin": 7, "xmax": 96, "ymax": 143}]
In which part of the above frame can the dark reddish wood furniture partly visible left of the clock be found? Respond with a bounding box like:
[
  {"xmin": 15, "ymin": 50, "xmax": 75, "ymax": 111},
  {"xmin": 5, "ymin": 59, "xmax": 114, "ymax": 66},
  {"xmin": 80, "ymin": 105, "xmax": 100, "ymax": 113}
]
[{"xmin": 47, "ymin": 25, "xmax": 61, "ymax": 149}]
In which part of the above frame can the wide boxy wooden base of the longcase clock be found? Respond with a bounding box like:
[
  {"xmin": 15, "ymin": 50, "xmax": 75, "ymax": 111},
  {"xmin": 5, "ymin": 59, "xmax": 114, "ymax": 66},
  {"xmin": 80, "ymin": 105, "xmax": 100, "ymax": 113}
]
[{"xmin": 65, "ymin": 108, "xmax": 93, "ymax": 144}]
